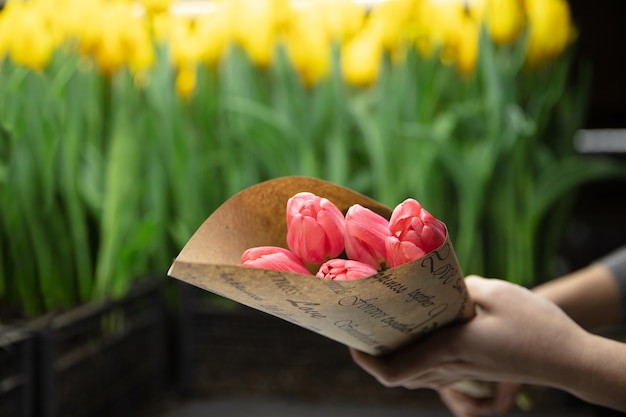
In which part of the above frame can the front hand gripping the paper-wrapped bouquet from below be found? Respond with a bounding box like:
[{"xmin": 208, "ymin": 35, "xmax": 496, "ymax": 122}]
[{"xmin": 351, "ymin": 276, "xmax": 586, "ymax": 394}]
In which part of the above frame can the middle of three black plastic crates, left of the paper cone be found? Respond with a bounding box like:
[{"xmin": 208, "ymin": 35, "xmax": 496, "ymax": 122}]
[{"xmin": 37, "ymin": 279, "xmax": 169, "ymax": 417}]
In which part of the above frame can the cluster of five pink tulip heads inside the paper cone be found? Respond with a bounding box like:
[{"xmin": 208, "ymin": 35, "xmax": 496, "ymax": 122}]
[{"xmin": 241, "ymin": 192, "xmax": 446, "ymax": 281}]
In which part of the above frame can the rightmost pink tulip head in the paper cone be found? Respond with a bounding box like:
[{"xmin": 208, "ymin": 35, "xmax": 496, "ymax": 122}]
[{"xmin": 386, "ymin": 198, "xmax": 446, "ymax": 267}]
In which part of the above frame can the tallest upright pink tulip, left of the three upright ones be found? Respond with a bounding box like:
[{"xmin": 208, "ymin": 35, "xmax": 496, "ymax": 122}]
[{"xmin": 287, "ymin": 192, "xmax": 344, "ymax": 264}]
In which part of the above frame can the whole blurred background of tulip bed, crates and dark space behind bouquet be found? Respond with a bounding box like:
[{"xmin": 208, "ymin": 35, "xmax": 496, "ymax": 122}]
[{"xmin": 0, "ymin": 0, "xmax": 626, "ymax": 417}]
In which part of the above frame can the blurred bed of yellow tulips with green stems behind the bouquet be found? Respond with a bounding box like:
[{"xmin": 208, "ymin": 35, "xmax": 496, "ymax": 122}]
[{"xmin": 0, "ymin": 0, "xmax": 624, "ymax": 320}]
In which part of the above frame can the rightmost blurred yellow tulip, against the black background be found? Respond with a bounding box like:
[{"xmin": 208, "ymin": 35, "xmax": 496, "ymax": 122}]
[{"xmin": 526, "ymin": 0, "xmax": 576, "ymax": 65}]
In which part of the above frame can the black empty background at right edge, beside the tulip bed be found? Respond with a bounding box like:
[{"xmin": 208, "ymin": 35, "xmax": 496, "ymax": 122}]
[{"xmin": 561, "ymin": 0, "xmax": 626, "ymax": 272}]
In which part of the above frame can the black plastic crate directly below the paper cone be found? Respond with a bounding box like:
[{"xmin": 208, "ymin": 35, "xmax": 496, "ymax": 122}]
[{"xmin": 178, "ymin": 283, "xmax": 439, "ymax": 405}]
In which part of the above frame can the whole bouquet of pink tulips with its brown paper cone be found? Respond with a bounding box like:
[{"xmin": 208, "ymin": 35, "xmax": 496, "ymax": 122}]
[{"xmin": 168, "ymin": 177, "xmax": 474, "ymax": 355}]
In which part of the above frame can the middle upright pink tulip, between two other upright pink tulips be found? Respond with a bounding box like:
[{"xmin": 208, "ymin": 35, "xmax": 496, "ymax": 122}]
[{"xmin": 345, "ymin": 204, "xmax": 390, "ymax": 270}]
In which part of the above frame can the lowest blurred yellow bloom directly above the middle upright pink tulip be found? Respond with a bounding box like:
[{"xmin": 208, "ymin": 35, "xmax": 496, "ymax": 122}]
[{"xmin": 341, "ymin": 27, "xmax": 383, "ymax": 87}]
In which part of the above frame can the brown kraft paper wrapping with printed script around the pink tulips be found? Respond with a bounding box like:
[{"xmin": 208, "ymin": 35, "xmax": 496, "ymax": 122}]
[{"xmin": 168, "ymin": 177, "xmax": 474, "ymax": 355}]
